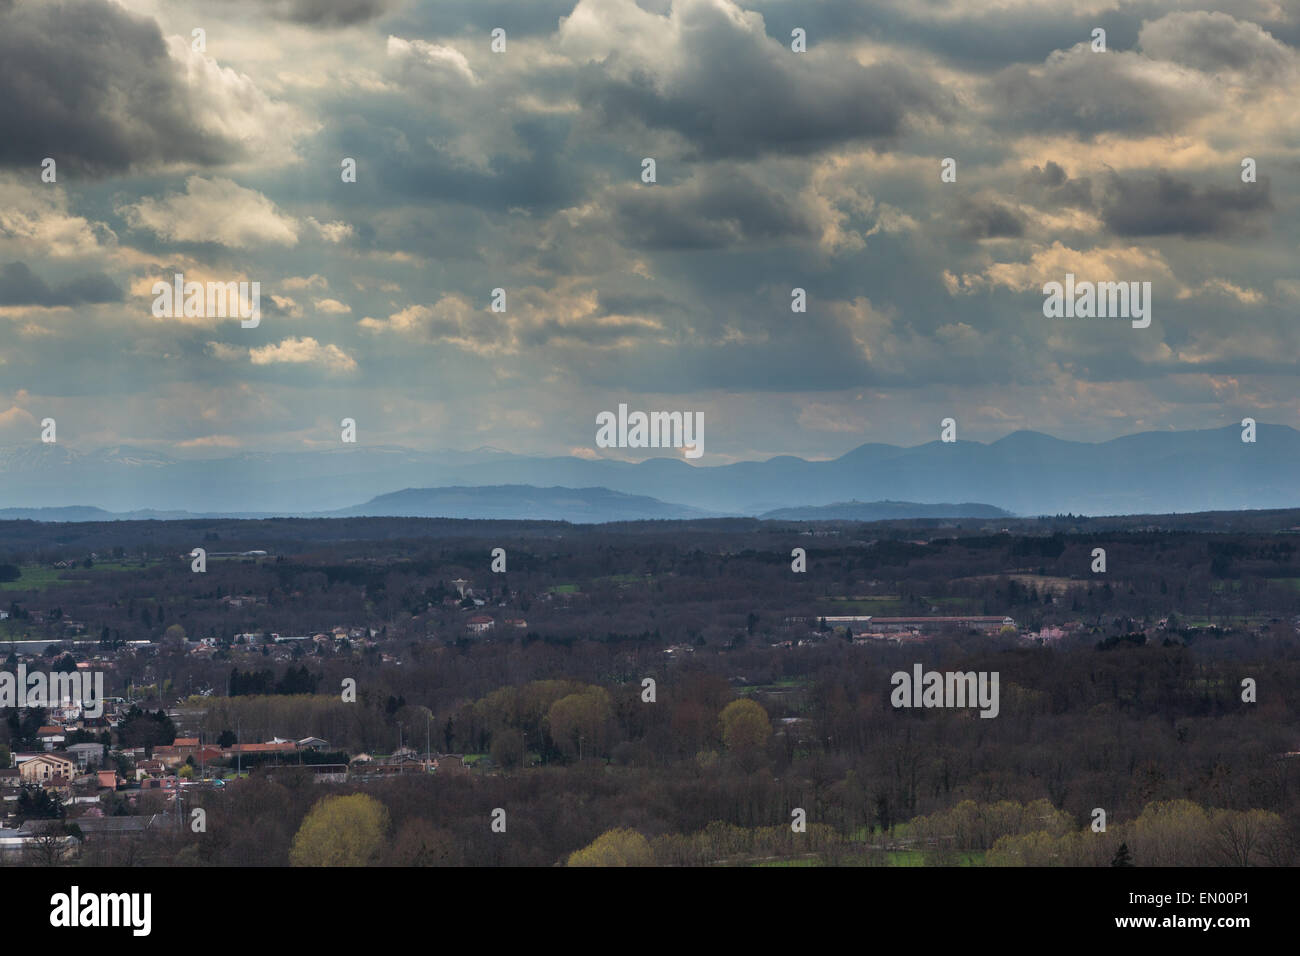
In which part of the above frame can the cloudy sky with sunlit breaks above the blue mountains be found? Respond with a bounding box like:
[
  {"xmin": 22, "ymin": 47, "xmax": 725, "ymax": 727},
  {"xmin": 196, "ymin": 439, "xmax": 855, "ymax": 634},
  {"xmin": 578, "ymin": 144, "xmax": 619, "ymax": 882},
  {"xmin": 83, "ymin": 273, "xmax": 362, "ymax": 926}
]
[{"xmin": 0, "ymin": 0, "xmax": 1300, "ymax": 464}]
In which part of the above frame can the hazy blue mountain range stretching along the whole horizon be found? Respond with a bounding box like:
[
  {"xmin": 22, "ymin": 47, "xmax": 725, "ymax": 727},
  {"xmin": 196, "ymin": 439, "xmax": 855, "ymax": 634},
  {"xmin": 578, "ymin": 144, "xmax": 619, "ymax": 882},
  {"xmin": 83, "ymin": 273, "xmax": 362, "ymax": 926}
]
[{"xmin": 0, "ymin": 424, "xmax": 1300, "ymax": 520}]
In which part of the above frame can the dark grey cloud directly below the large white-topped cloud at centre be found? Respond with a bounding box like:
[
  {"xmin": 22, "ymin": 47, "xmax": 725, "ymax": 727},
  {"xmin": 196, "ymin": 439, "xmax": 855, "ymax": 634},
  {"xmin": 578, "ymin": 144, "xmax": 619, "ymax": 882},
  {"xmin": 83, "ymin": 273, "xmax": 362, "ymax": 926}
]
[{"xmin": 614, "ymin": 168, "xmax": 818, "ymax": 250}]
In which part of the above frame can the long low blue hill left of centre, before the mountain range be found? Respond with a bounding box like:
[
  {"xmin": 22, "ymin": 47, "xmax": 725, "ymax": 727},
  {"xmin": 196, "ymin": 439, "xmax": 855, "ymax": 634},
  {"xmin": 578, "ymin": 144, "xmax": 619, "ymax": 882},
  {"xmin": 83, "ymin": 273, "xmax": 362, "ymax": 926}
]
[{"xmin": 322, "ymin": 485, "xmax": 714, "ymax": 524}]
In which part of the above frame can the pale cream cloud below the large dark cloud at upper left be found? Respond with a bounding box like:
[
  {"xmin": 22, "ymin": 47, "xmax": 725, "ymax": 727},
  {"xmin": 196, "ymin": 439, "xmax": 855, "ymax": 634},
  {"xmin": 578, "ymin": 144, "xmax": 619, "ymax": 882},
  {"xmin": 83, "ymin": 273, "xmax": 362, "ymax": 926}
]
[{"xmin": 118, "ymin": 176, "xmax": 299, "ymax": 247}]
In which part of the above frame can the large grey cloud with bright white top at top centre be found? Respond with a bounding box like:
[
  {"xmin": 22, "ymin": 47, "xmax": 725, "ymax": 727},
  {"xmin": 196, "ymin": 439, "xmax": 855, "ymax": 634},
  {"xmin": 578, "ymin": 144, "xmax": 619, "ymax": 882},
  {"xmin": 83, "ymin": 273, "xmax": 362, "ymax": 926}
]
[{"xmin": 559, "ymin": 0, "xmax": 952, "ymax": 157}]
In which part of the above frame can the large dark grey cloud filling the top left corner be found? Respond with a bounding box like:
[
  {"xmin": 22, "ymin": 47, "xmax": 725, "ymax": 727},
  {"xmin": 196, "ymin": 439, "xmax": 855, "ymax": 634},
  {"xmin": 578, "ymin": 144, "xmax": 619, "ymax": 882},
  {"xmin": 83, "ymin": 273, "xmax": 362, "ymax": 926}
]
[{"xmin": 0, "ymin": 0, "xmax": 238, "ymax": 173}]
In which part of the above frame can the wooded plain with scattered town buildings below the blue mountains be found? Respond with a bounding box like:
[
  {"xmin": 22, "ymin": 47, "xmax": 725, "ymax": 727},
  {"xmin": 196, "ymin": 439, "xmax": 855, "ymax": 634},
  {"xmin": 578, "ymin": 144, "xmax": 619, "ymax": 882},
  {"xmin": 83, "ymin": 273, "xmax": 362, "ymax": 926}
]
[{"xmin": 0, "ymin": 512, "xmax": 1300, "ymax": 865}]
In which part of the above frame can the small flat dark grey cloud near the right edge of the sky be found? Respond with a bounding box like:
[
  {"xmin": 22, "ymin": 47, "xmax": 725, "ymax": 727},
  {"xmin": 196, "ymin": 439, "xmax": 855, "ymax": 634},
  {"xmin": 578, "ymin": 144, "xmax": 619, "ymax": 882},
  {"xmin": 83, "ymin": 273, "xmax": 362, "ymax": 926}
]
[{"xmin": 1101, "ymin": 173, "xmax": 1273, "ymax": 238}]
